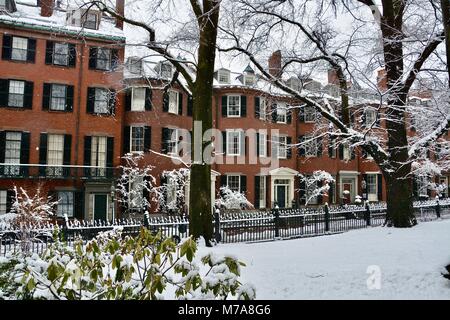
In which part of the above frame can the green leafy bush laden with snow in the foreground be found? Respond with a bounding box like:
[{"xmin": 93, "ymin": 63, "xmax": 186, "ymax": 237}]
[{"xmin": 0, "ymin": 228, "xmax": 255, "ymax": 300}]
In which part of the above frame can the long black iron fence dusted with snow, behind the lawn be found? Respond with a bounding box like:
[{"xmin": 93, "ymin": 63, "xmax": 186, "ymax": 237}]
[{"xmin": 0, "ymin": 199, "xmax": 450, "ymax": 255}]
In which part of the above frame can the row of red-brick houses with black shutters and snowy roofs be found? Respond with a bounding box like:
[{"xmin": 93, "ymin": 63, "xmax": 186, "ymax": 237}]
[{"xmin": 0, "ymin": 0, "xmax": 448, "ymax": 219}]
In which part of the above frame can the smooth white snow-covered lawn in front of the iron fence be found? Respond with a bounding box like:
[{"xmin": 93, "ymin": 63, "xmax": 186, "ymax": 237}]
[{"xmin": 199, "ymin": 220, "xmax": 450, "ymax": 299}]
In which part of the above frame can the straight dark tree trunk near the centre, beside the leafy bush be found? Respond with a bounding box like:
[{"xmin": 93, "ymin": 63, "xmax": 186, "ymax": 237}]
[{"xmin": 189, "ymin": 0, "xmax": 219, "ymax": 246}]
